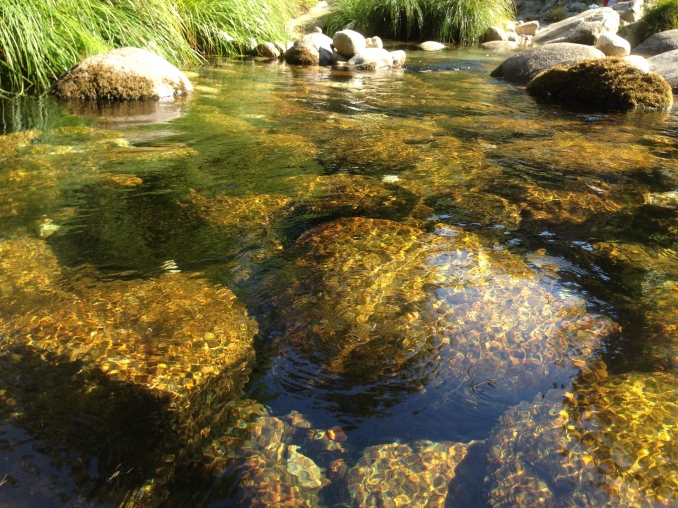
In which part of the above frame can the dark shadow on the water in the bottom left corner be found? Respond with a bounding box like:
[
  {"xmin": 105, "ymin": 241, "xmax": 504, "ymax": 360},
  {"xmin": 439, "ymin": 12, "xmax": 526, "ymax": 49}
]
[{"xmin": 0, "ymin": 346, "xmax": 180, "ymax": 507}]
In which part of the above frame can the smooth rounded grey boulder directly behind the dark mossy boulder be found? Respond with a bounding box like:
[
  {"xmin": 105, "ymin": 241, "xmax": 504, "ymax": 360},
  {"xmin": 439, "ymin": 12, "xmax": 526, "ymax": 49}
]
[{"xmin": 491, "ymin": 43, "xmax": 605, "ymax": 85}]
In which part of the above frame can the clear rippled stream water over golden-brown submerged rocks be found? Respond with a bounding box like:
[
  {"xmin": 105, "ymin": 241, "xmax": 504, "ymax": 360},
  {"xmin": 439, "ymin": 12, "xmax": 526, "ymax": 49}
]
[{"xmin": 0, "ymin": 48, "xmax": 678, "ymax": 507}]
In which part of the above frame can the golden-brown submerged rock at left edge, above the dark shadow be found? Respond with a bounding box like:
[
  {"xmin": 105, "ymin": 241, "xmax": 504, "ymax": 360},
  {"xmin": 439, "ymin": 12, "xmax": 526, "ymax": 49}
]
[{"xmin": 0, "ymin": 234, "xmax": 257, "ymax": 398}]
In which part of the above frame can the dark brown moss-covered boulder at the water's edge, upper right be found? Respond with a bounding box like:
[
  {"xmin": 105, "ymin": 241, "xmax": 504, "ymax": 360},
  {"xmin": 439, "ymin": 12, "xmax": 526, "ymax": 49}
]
[{"xmin": 527, "ymin": 58, "xmax": 673, "ymax": 109}]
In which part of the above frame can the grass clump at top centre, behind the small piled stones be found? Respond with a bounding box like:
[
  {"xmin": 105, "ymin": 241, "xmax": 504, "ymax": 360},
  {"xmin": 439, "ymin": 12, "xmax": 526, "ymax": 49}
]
[{"xmin": 327, "ymin": 0, "xmax": 515, "ymax": 44}]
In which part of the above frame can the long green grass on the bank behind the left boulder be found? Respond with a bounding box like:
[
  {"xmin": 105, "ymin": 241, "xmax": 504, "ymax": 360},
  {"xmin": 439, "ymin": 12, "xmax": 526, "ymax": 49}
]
[{"xmin": 0, "ymin": 0, "xmax": 300, "ymax": 96}]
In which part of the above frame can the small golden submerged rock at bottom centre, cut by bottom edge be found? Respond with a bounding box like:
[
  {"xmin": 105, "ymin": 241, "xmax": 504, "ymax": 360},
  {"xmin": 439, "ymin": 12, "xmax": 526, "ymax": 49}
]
[{"xmin": 346, "ymin": 441, "xmax": 473, "ymax": 508}]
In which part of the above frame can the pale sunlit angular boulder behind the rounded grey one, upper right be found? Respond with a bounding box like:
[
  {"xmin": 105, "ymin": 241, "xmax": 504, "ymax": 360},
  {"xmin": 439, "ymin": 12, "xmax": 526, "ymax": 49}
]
[{"xmin": 532, "ymin": 7, "xmax": 619, "ymax": 45}]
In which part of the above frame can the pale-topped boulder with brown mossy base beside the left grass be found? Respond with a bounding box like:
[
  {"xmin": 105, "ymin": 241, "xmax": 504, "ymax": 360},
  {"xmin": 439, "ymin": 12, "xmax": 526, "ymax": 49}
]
[{"xmin": 52, "ymin": 48, "xmax": 193, "ymax": 101}]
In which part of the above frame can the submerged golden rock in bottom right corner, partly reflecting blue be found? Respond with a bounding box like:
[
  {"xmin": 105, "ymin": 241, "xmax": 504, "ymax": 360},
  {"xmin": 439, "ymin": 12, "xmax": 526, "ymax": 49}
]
[{"xmin": 487, "ymin": 373, "xmax": 678, "ymax": 507}]
